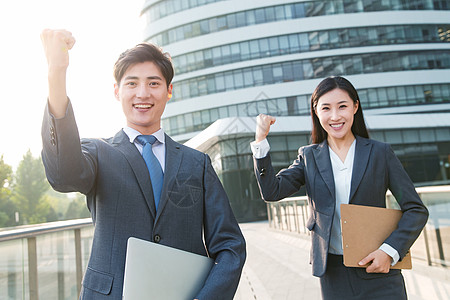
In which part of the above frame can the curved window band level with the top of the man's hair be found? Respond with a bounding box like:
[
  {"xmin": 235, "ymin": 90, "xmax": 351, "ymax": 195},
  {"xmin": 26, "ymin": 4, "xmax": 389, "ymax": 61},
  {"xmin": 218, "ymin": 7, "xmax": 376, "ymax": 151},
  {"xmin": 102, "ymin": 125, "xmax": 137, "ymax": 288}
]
[{"xmin": 173, "ymin": 25, "xmax": 450, "ymax": 74}]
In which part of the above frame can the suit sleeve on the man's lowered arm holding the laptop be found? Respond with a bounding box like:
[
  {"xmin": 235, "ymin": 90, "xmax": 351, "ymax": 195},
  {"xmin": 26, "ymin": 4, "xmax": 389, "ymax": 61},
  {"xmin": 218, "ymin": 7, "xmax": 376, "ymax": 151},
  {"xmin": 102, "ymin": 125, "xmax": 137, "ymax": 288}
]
[{"xmin": 197, "ymin": 154, "xmax": 246, "ymax": 300}]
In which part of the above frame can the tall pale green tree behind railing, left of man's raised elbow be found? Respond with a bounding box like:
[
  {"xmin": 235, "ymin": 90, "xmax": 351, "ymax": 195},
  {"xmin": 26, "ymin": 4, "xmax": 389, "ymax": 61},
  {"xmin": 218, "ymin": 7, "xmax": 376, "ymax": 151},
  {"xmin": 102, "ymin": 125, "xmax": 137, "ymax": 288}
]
[{"xmin": 13, "ymin": 150, "xmax": 51, "ymax": 224}]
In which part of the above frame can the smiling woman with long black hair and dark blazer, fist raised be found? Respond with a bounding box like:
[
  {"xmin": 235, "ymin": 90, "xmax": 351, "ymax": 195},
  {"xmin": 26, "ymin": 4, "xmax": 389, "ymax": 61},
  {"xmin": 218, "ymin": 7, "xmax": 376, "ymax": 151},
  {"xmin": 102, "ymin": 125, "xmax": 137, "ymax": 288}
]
[{"xmin": 251, "ymin": 77, "xmax": 428, "ymax": 300}]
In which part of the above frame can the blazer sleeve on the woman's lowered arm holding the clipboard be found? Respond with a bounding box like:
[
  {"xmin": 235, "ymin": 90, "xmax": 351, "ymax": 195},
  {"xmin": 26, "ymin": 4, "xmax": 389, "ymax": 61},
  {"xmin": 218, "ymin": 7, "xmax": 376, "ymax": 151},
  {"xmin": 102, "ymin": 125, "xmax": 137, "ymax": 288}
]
[{"xmin": 385, "ymin": 144, "xmax": 428, "ymax": 259}]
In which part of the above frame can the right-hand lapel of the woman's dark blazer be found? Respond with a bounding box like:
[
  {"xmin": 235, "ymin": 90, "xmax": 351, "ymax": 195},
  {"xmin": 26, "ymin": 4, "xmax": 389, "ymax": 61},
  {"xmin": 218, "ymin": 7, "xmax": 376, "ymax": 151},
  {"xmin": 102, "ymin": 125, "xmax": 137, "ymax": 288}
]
[{"xmin": 349, "ymin": 136, "xmax": 372, "ymax": 203}]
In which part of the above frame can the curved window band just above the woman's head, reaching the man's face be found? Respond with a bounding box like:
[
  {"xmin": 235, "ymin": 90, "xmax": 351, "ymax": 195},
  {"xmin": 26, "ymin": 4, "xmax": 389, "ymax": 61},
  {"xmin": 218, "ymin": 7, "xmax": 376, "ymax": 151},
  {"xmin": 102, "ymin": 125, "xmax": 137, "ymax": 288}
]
[{"xmin": 172, "ymin": 49, "xmax": 450, "ymax": 100}]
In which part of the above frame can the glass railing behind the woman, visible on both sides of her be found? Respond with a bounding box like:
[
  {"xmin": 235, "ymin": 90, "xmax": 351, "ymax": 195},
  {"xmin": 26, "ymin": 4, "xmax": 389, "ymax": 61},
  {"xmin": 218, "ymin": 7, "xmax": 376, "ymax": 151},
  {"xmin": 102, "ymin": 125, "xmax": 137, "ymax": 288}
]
[{"xmin": 267, "ymin": 185, "xmax": 450, "ymax": 267}]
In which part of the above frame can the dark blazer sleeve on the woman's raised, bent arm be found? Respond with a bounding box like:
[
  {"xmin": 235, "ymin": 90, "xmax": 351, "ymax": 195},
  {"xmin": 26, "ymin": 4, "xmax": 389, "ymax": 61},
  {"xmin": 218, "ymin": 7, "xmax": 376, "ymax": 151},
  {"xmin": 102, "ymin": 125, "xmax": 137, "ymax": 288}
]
[{"xmin": 253, "ymin": 148, "xmax": 305, "ymax": 201}]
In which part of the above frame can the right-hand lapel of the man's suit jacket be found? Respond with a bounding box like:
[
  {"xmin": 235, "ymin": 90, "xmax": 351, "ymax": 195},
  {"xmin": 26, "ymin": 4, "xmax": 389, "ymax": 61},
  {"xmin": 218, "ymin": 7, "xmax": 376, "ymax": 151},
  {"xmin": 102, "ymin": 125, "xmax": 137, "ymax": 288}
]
[{"xmin": 155, "ymin": 134, "xmax": 183, "ymax": 222}]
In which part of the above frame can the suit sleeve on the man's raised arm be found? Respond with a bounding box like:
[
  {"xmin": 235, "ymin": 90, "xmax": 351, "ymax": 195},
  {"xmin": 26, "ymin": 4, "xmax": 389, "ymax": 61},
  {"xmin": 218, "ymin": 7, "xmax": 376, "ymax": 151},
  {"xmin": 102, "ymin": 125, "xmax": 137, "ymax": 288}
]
[{"xmin": 41, "ymin": 101, "xmax": 96, "ymax": 194}]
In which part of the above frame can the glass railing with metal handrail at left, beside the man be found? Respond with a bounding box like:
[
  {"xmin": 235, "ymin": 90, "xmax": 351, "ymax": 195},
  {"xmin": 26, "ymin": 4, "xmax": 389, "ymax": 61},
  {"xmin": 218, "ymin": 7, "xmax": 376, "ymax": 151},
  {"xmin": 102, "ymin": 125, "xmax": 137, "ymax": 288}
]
[{"xmin": 0, "ymin": 218, "xmax": 93, "ymax": 300}]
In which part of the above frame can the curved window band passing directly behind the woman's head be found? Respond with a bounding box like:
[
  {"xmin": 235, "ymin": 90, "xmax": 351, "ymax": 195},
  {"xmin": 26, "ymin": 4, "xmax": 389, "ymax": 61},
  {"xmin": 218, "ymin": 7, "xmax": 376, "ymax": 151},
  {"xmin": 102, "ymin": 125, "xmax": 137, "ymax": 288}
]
[{"xmin": 162, "ymin": 84, "xmax": 450, "ymax": 137}]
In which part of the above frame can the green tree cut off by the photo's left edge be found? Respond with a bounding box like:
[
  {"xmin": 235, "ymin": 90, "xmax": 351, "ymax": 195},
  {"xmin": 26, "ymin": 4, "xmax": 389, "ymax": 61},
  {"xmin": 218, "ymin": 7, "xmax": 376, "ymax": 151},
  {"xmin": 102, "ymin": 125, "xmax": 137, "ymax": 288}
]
[{"xmin": 0, "ymin": 155, "xmax": 16, "ymax": 227}]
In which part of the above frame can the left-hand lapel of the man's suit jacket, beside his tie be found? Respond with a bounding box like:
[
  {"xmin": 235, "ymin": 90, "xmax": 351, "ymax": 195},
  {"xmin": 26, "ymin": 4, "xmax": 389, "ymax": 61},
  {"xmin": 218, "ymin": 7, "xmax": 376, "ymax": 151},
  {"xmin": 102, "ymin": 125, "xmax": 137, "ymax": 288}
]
[{"xmin": 112, "ymin": 130, "xmax": 156, "ymax": 219}]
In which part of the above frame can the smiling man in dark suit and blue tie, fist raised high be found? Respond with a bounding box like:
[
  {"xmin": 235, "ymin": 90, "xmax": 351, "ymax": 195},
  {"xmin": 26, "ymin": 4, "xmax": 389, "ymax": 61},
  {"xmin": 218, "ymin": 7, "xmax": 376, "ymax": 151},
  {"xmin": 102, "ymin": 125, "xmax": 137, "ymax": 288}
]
[{"xmin": 41, "ymin": 29, "xmax": 246, "ymax": 299}]
